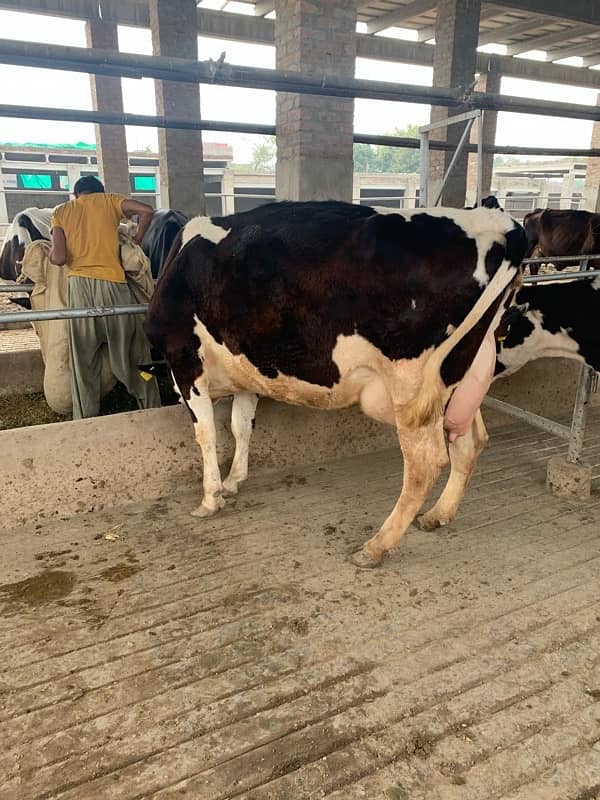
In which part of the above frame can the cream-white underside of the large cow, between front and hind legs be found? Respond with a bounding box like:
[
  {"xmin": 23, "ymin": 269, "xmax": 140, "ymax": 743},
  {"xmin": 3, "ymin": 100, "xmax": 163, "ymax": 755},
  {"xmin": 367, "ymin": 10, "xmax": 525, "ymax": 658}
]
[{"xmin": 195, "ymin": 322, "xmax": 412, "ymax": 422}]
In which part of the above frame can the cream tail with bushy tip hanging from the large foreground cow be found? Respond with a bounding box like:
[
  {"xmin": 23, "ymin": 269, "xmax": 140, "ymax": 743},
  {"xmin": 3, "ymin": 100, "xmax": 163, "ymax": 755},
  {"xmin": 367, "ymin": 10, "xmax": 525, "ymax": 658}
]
[{"xmin": 396, "ymin": 238, "xmax": 518, "ymax": 428}]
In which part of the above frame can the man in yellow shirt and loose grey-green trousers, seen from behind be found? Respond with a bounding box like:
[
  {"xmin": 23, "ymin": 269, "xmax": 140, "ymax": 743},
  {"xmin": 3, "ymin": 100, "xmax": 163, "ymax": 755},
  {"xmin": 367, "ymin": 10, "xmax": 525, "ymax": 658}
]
[{"xmin": 50, "ymin": 176, "xmax": 160, "ymax": 419}]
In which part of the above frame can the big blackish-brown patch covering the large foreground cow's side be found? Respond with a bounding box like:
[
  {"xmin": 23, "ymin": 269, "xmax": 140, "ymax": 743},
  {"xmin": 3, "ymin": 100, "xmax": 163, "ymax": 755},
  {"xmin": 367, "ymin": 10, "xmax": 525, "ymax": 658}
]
[{"xmin": 146, "ymin": 202, "xmax": 524, "ymax": 391}]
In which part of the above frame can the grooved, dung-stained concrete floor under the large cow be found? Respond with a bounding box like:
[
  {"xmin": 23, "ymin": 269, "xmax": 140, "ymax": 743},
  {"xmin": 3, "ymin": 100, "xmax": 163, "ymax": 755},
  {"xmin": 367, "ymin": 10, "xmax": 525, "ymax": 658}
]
[{"xmin": 0, "ymin": 413, "xmax": 600, "ymax": 800}]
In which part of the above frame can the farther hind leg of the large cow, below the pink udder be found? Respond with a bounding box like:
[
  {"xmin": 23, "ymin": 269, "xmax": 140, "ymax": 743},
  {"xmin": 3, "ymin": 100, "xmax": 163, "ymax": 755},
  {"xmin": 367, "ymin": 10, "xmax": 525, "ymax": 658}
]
[{"xmin": 417, "ymin": 411, "xmax": 489, "ymax": 531}]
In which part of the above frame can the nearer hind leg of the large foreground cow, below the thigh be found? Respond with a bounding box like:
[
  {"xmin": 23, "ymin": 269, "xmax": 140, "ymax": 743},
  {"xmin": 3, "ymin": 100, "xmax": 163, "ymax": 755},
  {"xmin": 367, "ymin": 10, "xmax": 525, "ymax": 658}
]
[{"xmin": 352, "ymin": 419, "xmax": 448, "ymax": 567}]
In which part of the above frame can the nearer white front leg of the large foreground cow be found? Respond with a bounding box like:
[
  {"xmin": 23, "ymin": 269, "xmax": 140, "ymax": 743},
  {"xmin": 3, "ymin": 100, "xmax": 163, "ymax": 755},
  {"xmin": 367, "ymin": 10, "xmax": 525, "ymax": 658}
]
[{"xmin": 187, "ymin": 377, "xmax": 225, "ymax": 517}]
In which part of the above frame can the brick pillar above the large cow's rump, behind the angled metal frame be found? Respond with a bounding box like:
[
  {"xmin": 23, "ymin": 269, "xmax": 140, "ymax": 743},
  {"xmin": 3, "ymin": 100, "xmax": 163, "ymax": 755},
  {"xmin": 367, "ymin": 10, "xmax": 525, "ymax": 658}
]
[{"xmin": 428, "ymin": 0, "xmax": 481, "ymax": 207}]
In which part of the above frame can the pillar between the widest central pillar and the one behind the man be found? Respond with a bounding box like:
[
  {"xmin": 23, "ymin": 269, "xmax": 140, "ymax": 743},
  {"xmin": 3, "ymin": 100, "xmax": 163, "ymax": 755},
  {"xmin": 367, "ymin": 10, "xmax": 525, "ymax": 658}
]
[{"xmin": 149, "ymin": 0, "xmax": 206, "ymax": 216}]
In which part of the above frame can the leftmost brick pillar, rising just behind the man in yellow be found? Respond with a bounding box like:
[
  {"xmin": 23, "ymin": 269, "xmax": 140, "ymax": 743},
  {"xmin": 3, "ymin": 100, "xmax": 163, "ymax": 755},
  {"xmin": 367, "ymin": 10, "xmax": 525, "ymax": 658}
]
[{"xmin": 84, "ymin": 19, "xmax": 131, "ymax": 195}]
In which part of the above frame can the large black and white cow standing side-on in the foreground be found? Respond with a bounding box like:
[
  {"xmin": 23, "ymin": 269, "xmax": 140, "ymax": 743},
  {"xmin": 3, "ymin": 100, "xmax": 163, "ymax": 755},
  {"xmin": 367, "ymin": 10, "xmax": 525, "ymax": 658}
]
[{"xmin": 145, "ymin": 201, "xmax": 527, "ymax": 566}]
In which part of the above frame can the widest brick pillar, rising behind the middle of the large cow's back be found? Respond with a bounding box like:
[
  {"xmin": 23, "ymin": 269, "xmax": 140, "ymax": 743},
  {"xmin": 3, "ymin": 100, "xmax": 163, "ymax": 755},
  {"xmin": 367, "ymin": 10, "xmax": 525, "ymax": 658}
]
[{"xmin": 275, "ymin": 0, "xmax": 356, "ymax": 201}]
